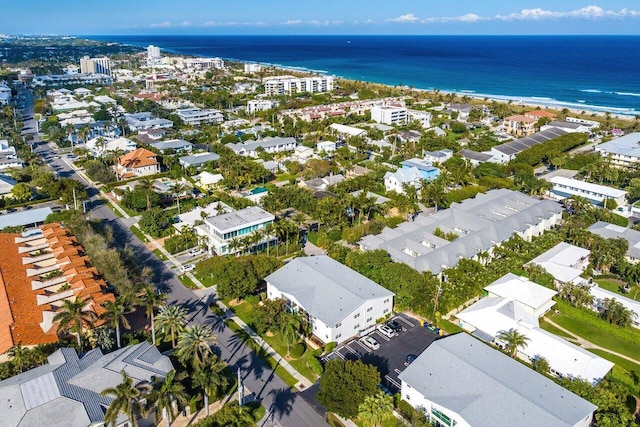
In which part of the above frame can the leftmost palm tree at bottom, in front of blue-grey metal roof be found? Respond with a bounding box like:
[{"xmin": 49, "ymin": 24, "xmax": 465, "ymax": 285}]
[{"xmin": 100, "ymin": 371, "xmax": 151, "ymax": 427}]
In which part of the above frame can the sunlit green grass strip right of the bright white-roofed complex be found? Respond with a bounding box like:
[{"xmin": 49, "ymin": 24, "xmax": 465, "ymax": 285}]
[{"xmin": 550, "ymin": 312, "xmax": 640, "ymax": 359}]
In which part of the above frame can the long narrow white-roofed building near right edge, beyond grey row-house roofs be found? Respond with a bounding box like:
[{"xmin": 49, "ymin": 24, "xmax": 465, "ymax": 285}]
[{"xmin": 548, "ymin": 176, "xmax": 627, "ymax": 206}]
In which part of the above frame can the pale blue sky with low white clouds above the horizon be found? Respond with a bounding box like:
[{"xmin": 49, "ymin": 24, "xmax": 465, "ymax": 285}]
[{"xmin": 0, "ymin": 0, "xmax": 640, "ymax": 35}]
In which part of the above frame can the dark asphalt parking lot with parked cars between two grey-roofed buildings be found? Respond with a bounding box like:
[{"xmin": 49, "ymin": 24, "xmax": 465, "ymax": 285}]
[{"xmin": 322, "ymin": 314, "xmax": 438, "ymax": 393}]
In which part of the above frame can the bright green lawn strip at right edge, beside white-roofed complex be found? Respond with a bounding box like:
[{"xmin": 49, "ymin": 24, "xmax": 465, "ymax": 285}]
[{"xmin": 550, "ymin": 304, "xmax": 640, "ymax": 359}]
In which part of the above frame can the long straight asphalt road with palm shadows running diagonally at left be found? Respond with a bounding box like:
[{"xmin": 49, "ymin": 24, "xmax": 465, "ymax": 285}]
[{"xmin": 24, "ymin": 88, "xmax": 327, "ymax": 427}]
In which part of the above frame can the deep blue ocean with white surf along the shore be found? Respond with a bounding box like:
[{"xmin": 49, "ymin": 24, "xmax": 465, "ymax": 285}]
[{"xmin": 90, "ymin": 36, "xmax": 640, "ymax": 116}]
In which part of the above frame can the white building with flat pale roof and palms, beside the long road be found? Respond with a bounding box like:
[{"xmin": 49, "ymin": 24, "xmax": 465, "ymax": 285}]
[{"xmin": 197, "ymin": 206, "xmax": 275, "ymax": 255}]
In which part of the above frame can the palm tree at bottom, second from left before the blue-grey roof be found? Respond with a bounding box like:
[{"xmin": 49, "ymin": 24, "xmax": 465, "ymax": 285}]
[{"xmin": 147, "ymin": 369, "xmax": 189, "ymax": 427}]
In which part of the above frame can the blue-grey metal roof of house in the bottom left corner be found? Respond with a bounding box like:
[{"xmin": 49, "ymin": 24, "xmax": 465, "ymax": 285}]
[{"xmin": 0, "ymin": 341, "xmax": 174, "ymax": 427}]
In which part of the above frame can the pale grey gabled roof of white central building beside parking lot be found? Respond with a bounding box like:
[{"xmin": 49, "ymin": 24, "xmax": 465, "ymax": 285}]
[{"xmin": 265, "ymin": 255, "xmax": 394, "ymax": 326}]
